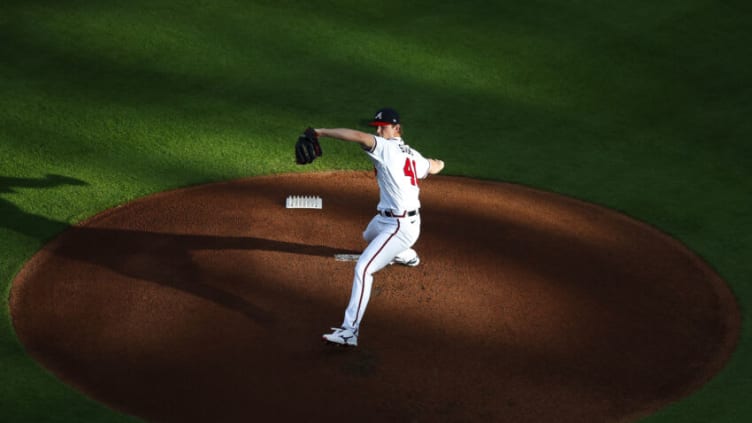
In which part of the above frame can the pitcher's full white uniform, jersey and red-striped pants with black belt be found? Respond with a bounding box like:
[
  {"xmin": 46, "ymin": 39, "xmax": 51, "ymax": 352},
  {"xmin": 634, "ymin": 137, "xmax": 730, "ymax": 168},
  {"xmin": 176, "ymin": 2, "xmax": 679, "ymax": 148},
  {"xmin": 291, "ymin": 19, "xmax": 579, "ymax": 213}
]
[{"xmin": 342, "ymin": 136, "xmax": 430, "ymax": 334}]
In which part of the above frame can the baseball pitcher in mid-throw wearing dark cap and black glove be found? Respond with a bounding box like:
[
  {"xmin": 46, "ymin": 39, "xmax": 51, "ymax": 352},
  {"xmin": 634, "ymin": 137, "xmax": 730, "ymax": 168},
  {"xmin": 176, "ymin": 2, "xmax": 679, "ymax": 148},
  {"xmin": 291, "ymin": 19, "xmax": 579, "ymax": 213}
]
[{"xmin": 295, "ymin": 108, "xmax": 444, "ymax": 347}]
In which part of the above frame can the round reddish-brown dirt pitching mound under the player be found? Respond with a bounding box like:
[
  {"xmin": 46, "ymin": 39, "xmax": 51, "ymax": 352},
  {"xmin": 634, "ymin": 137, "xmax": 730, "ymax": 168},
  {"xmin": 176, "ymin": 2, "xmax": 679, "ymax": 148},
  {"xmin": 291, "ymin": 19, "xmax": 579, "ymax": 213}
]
[{"xmin": 10, "ymin": 172, "xmax": 740, "ymax": 422}]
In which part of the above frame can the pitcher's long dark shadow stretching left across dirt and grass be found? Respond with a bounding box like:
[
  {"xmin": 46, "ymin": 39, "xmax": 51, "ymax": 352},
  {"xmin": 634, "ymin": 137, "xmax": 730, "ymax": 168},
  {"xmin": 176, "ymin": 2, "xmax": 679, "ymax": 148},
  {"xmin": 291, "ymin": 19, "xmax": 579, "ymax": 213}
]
[{"xmin": 0, "ymin": 174, "xmax": 356, "ymax": 326}]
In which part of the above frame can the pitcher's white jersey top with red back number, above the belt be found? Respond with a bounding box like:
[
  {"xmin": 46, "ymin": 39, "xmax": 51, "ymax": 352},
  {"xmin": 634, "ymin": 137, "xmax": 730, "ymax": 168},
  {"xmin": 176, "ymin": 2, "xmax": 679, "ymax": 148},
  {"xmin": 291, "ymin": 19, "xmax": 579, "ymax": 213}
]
[{"xmin": 366, "ymin": 136, "xmax": 430, "ymax": 214}]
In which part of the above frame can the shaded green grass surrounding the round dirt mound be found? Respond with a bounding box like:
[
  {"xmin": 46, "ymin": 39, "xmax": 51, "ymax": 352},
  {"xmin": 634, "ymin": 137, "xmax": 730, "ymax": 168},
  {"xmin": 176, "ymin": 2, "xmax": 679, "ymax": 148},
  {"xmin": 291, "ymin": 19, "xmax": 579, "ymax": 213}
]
[{"xmin": 0, "ymin": 0, "xmax": 752, "ymax": 422}]
